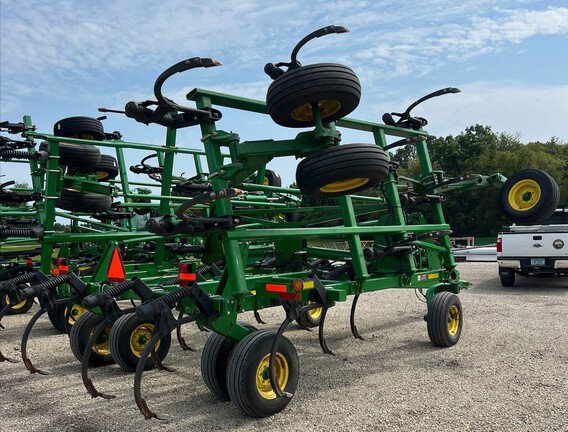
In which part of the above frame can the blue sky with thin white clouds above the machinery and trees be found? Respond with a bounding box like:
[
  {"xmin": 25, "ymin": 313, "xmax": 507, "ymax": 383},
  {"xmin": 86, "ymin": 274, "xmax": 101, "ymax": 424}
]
[{"xmin": 0, "ymin": 0, "xmax": 568, "ymax": 184}]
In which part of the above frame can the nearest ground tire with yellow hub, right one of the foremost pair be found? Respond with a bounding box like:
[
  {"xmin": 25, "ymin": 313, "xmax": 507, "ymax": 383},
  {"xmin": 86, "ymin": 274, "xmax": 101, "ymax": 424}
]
[{"xmin": 227, "ymin": 330, "xmax": 300, "ymax": 417}]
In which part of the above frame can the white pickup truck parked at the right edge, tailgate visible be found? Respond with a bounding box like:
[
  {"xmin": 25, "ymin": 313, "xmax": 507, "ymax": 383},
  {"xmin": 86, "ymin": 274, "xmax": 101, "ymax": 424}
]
[{"xmin": 497, "ymin": 208, "xmax": 568, "ymax": 287}]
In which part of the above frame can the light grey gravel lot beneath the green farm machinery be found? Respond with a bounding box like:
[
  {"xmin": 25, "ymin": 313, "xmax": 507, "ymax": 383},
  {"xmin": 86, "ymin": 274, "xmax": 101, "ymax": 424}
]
[{"xmin": 0, "ymin": 262, "xmax": 568, "ymax": 432}]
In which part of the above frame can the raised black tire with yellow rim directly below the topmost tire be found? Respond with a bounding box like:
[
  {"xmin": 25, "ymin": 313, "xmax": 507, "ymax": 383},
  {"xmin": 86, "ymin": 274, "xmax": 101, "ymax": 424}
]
[{"xmin": 296, "ymin": 144, "xmax": 389, "ymax": 198}]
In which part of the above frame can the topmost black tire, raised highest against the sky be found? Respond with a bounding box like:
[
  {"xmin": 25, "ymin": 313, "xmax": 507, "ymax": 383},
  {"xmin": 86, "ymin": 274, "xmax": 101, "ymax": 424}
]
[{"xmin": 266, "ymin": 63, "xmax": 361, "ymax": 127}]
